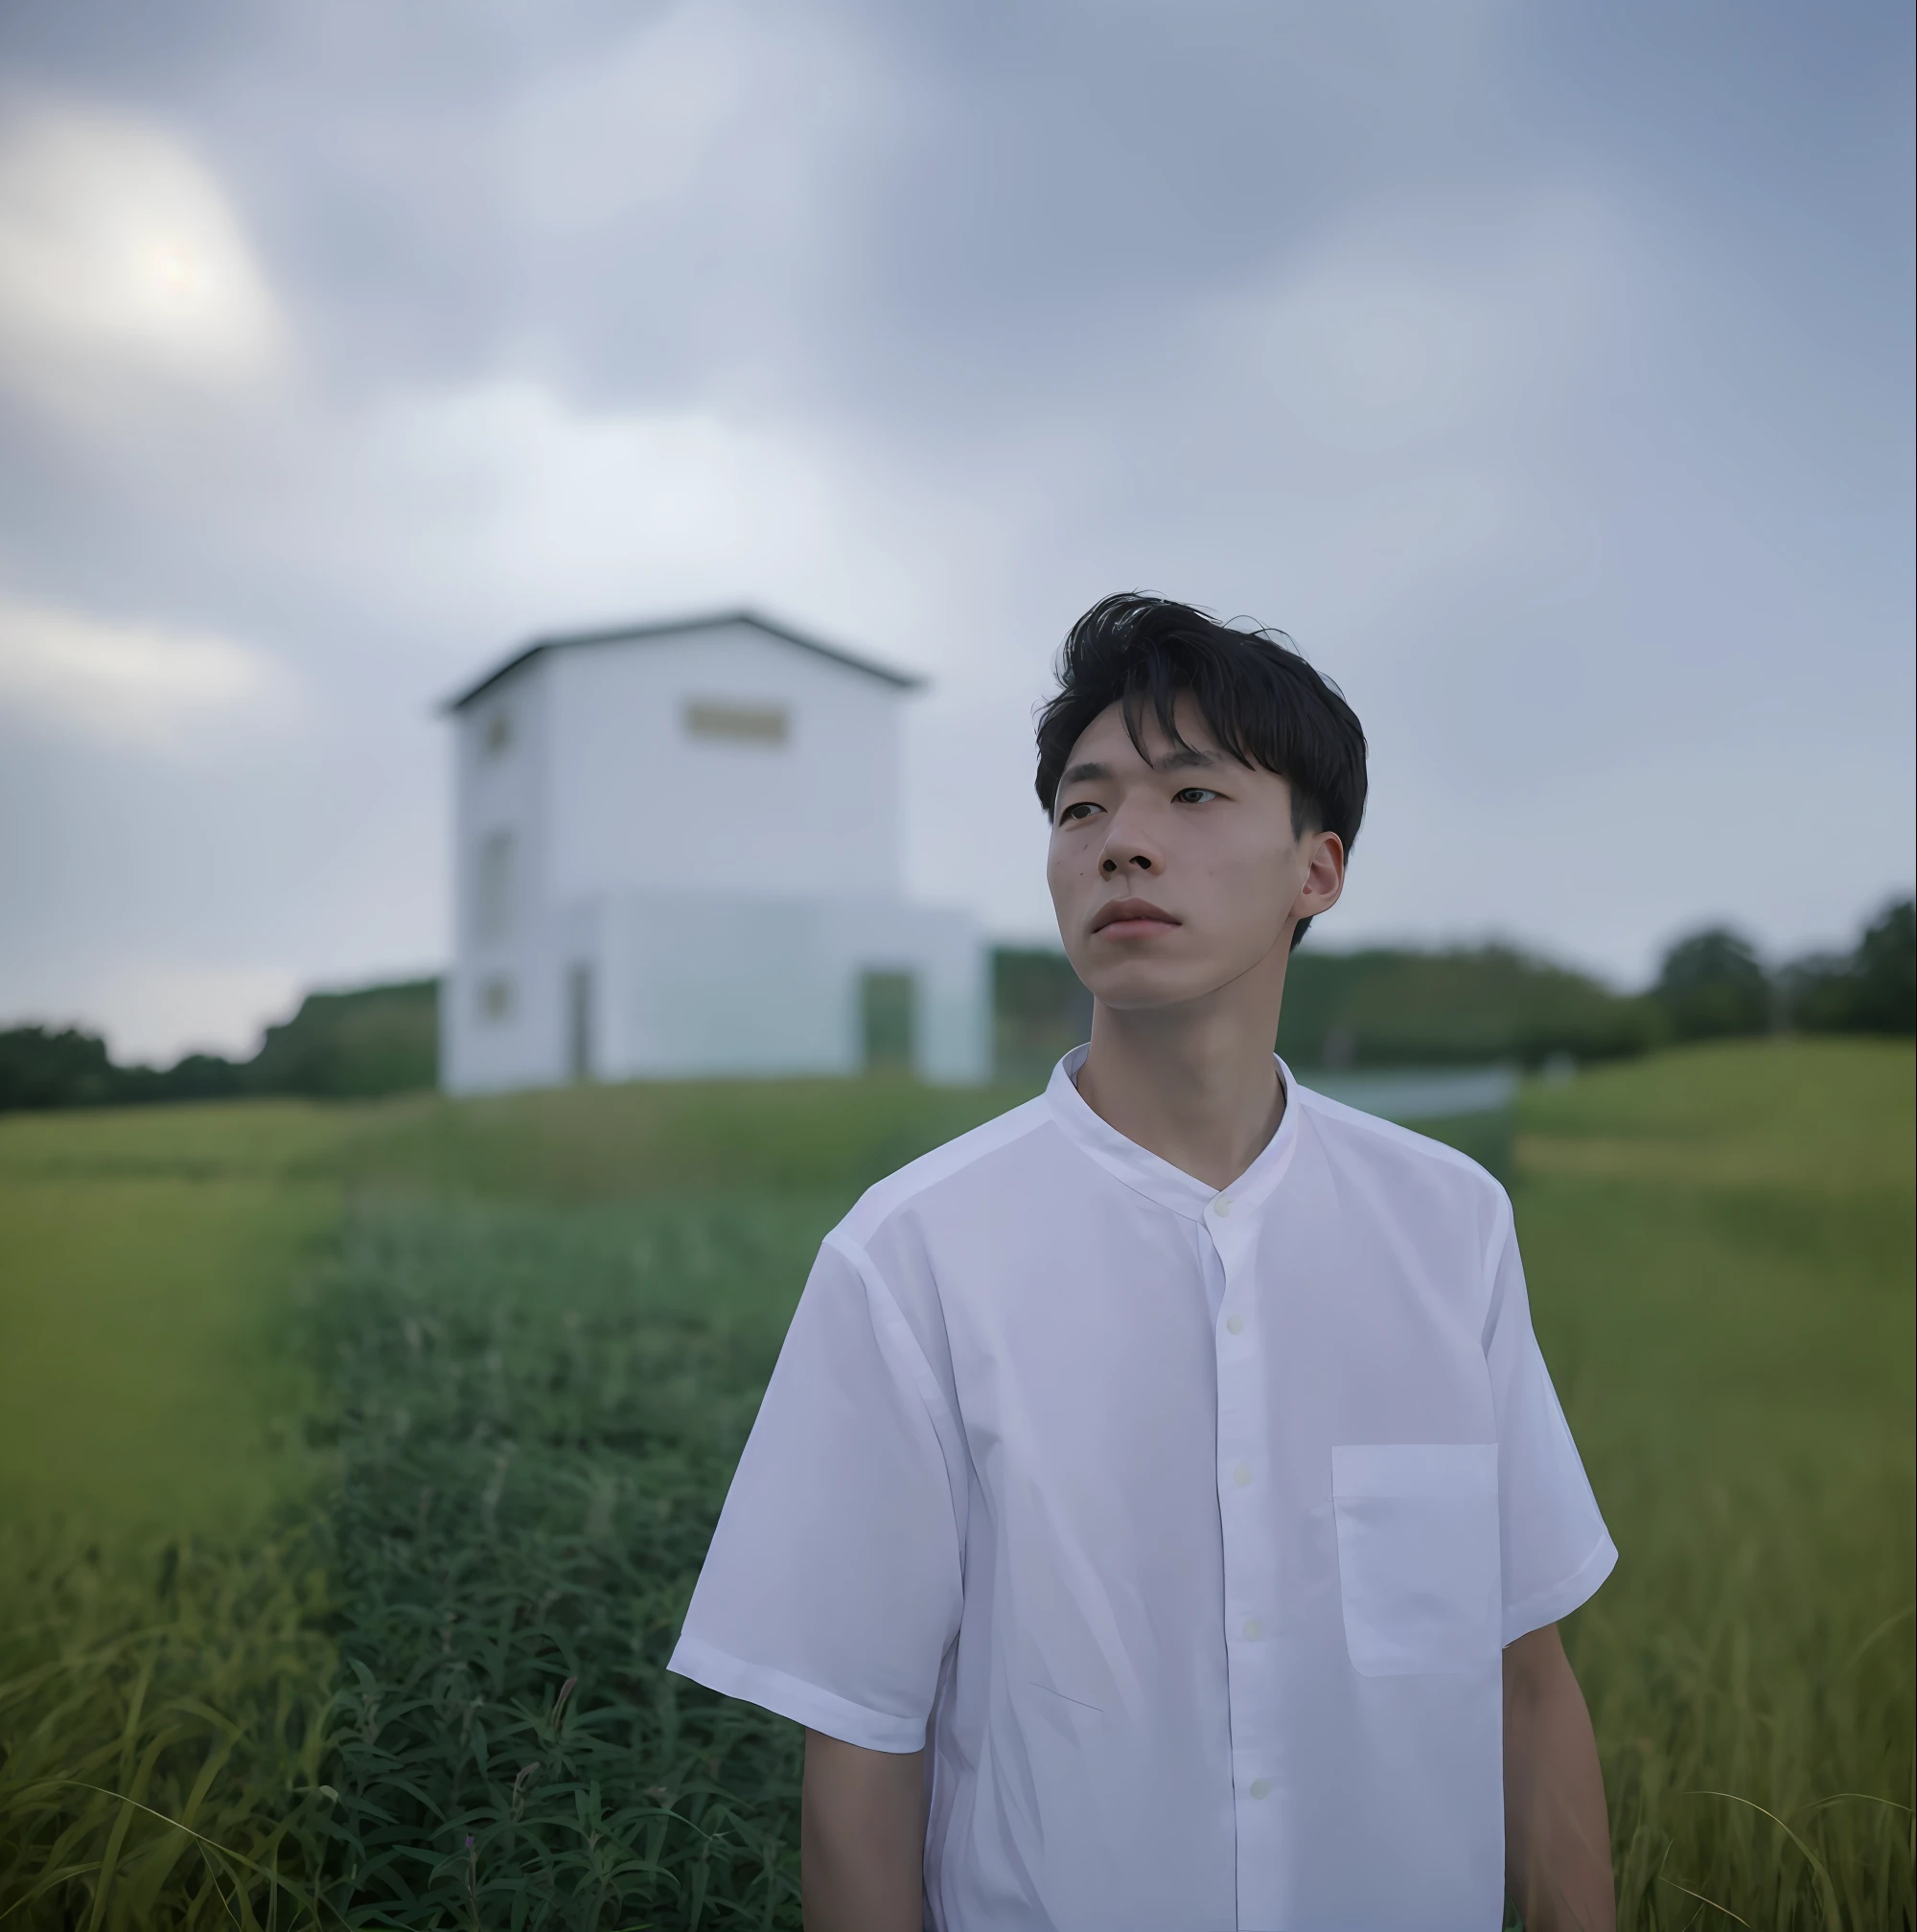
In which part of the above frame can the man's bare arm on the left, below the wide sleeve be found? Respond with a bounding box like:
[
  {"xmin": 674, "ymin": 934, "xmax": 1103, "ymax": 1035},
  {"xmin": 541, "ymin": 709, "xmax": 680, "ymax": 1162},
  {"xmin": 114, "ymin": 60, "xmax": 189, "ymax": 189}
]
[{"xmin": 798, "ymin": 1731, "xmax": 926, "ymax": 1932}]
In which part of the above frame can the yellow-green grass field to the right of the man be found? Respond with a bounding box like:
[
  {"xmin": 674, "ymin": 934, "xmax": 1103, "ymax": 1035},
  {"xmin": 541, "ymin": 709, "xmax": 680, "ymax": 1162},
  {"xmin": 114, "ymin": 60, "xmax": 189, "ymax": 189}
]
[{"xmin": 1517, "ymin": 1044, "xmax": 1917, "ymax": 1928}]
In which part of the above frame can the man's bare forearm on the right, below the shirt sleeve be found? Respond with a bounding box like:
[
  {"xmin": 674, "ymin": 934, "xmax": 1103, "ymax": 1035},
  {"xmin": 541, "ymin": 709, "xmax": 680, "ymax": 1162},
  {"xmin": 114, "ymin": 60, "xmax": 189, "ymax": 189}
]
[{"xmin": 1504, "ymin": 1622, "xmax": 1618, "ymax": 1932}]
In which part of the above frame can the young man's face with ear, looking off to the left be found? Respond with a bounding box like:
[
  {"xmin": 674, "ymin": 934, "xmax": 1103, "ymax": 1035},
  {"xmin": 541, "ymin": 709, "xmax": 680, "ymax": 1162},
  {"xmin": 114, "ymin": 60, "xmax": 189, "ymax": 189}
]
[{"xmin": 1046, "ymin": 698, "xmax": 1345, "ymax": 1008}]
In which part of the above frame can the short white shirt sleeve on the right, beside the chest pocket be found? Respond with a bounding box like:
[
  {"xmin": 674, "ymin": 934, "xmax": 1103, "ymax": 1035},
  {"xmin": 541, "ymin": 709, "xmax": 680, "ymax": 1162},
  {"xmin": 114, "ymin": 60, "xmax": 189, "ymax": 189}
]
[{"xmin": 1484, "ymin": 1202, "xmax": 1618, "ymax": 1644}]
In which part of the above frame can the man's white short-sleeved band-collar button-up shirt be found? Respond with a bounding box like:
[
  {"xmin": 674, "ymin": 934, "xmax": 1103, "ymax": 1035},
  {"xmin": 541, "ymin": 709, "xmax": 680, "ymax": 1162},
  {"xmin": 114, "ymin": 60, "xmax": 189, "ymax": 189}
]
[{"xmin": 673, "ymin": 1049, "xmax": 1618, "ymax": 1932}]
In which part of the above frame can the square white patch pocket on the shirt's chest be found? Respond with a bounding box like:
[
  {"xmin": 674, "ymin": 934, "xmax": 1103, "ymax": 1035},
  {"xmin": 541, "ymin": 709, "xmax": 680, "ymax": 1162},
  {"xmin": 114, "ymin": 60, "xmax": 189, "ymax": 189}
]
[{"xmin": 1331, "ymin": 1443, "xmax": 1502, "ymax": 1677}]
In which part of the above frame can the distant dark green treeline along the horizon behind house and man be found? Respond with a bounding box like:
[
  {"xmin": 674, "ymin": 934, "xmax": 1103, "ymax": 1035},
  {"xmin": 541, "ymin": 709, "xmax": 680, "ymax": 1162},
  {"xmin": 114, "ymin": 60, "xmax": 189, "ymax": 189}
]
[{"xmin": 0, "ymin": 898, "xmax": 1917, "ymax": 1111}]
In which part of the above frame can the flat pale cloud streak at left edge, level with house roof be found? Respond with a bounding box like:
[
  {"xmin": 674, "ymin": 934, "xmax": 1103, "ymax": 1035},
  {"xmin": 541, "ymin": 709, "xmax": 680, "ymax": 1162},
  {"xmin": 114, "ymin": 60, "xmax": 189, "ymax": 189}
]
[{"xmin": 0, "ymin": 597, "xmax": 289, "ymax": 761}]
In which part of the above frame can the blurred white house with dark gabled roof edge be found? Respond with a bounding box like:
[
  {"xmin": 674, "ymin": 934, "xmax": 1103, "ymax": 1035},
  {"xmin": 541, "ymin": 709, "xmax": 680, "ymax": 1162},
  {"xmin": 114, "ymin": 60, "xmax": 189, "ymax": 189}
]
[{"xmin": 441, "ymin": 610, "xmax": 989, "ymax": 1093}]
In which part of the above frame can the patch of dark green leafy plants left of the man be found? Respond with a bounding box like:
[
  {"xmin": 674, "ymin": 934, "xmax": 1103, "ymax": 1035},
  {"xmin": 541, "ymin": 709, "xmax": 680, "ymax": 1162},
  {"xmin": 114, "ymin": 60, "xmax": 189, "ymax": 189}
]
[{"xmin": 315, "ymin": 1196, "xmax": 835, "ymax": 1932}]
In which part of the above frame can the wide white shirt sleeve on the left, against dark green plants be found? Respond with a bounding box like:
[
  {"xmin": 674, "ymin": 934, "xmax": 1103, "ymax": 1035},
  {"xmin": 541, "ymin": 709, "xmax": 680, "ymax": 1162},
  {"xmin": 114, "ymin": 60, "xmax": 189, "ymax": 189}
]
[{"xmin": 669, "ymin": 1236, "xmax": 964, "ymax": 1753}]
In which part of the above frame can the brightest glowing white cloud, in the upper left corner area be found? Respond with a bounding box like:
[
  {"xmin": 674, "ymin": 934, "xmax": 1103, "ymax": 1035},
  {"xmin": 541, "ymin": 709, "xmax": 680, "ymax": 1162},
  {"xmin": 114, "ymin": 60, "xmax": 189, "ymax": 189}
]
[{"xmin": 0, "ymin": 97, "xmax": 286, "ymax": 409}]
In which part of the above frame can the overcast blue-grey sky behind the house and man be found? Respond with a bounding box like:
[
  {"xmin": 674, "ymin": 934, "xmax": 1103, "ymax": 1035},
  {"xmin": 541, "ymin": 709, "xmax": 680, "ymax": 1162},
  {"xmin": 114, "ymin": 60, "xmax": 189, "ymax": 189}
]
[{"xmin": 0, "ymin": 0, "xmax": 1913, "ymax": 1059}]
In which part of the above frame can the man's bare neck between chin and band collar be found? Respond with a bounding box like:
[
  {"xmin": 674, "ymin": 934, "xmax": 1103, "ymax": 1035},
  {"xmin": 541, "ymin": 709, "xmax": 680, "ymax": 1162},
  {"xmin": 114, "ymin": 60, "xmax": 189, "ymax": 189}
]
[{"xmin": 1078, "ymin": 953, "xmax": 1287, "ymax": 1188}]
